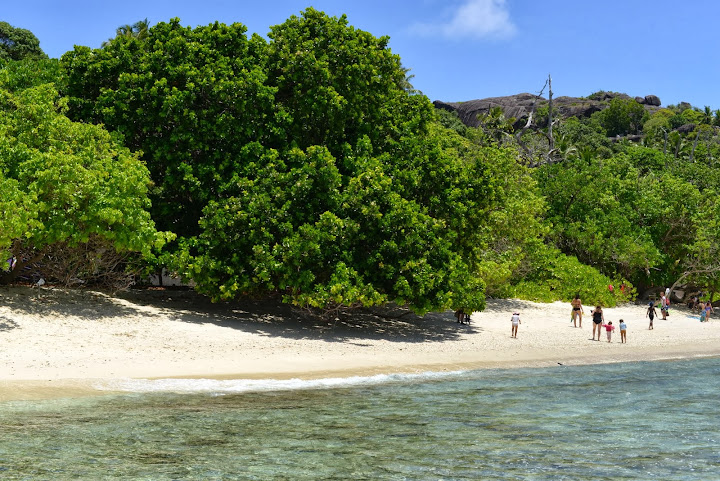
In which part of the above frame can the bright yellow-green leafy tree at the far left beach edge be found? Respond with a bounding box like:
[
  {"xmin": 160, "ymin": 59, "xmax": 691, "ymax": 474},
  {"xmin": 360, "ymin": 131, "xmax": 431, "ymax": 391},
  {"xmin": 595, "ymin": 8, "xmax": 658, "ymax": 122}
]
[{"xmin": 0, "ymin": 74, "xmax": 167, "ymax": 281}]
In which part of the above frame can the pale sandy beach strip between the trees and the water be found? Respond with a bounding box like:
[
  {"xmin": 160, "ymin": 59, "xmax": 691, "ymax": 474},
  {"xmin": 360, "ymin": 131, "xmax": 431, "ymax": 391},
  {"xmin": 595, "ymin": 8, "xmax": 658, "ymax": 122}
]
[{"xmin": 0, "ymin": 287, "xmax": 720, "ymax": 400}]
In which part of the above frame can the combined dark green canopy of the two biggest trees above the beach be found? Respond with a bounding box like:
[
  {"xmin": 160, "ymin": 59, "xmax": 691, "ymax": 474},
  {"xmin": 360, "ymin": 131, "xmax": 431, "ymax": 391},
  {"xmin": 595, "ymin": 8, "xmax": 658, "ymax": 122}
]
[{"xmin": 62, "ymin": 9, "xmax": 494, "ymax": 312}]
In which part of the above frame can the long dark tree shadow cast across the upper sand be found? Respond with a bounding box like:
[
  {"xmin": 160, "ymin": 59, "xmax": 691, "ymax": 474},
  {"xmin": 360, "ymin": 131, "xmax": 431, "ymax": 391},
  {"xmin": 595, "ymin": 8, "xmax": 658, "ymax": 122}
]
[{"xmin": 0, "ymin": 287, "xmax": 482, "ymax": 345}]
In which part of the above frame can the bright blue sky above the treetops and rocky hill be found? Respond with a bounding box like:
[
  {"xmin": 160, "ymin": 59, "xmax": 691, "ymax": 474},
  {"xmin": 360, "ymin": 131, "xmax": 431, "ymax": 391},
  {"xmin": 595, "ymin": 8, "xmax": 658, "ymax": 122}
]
[{"xmin": 5, "ymin": 0, "xmax": 720, "ymax": 109}]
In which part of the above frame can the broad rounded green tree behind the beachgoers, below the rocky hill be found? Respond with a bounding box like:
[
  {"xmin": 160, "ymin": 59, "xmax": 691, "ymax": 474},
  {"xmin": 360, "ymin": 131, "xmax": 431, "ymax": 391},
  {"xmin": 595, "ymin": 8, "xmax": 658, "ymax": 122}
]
[{"xmin": 537, "ymin": 147, "xmax": 703, "ymax": 285}]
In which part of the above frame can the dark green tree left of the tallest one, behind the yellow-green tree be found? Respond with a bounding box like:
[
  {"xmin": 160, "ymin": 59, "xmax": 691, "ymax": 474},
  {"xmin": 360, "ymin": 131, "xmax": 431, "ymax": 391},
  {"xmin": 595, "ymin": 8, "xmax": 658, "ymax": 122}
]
[{"xmin": 61, "ymin": 19, "xmax": 277, "ymax": 235}]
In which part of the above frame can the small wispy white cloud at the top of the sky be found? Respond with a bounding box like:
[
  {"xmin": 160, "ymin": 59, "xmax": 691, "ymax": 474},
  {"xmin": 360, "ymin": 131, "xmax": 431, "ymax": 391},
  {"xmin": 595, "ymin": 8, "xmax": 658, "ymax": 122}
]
[{"xmin": 412, "ymin": 0, "xmax": 517, "ymax": 38}]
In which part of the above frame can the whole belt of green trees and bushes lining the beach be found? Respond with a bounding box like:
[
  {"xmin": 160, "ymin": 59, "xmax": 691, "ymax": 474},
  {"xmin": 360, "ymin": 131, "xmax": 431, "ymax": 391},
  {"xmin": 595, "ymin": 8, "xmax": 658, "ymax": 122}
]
[{"xmin": 0, "ymin": 9, "xmax": 720, "ymax": 313}]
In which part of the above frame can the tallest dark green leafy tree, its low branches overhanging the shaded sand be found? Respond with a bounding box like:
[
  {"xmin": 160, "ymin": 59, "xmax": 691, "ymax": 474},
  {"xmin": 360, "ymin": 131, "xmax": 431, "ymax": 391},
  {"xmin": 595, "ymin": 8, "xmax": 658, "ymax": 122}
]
[{"xmin": 179, "ymin": 9, "xmax": 493, "ymax": 312}]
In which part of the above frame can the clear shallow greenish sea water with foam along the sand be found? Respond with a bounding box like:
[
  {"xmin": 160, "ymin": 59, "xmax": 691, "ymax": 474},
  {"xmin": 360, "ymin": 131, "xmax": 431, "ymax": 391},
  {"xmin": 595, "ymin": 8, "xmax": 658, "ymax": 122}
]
[{"xmin": 0, "ymin": 359, "xmax": 720, "ymax": 480}]
